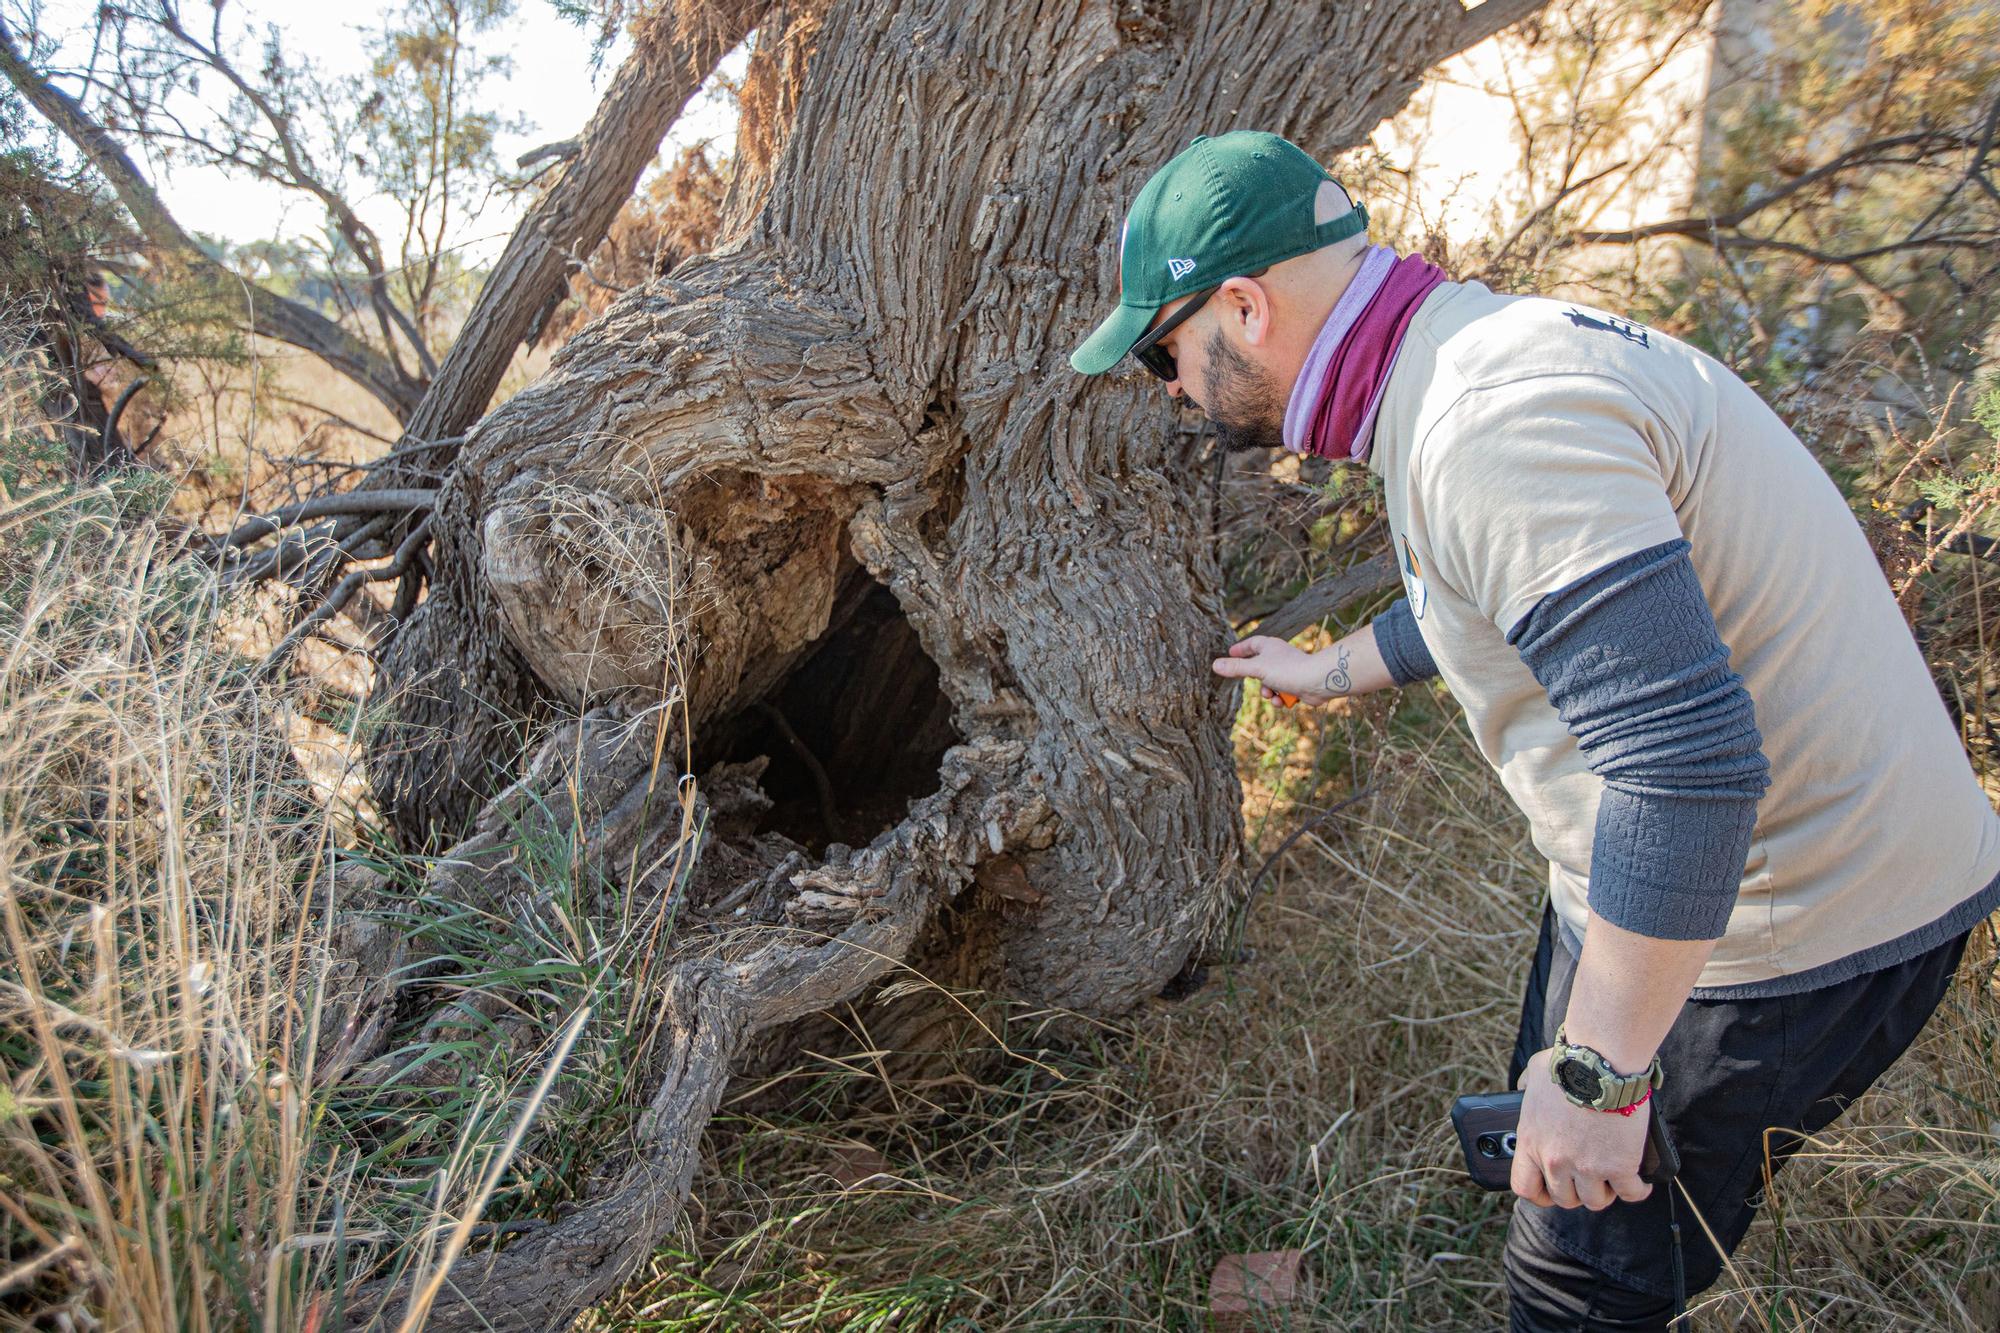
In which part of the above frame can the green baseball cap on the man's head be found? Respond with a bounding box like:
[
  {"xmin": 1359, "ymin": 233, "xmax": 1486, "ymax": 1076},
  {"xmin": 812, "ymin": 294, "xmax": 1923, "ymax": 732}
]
[{"xmin": 1070, "ymin": 130, "xmax": 1368, "ymax": 374}]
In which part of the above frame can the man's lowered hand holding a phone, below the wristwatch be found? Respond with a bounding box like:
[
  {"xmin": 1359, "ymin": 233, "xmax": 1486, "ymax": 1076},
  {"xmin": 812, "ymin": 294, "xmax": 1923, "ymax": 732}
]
[{"xmin": 1512, "ymin": 1051, "xmax": 1652, "ymax": 1213}]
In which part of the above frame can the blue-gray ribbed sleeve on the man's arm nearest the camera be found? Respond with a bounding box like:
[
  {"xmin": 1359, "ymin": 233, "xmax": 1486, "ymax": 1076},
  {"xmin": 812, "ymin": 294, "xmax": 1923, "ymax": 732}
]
[{"xmin": 1506, "ymin": 540, "xmax": 1770, "ymax": 939}]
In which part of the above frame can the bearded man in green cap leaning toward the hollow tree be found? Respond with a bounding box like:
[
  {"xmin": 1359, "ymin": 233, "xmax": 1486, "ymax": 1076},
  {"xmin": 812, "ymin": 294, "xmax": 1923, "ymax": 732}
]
[{"xmin": 1072, "ymin": 132, "xmax": 2000, "ymax": 1329}]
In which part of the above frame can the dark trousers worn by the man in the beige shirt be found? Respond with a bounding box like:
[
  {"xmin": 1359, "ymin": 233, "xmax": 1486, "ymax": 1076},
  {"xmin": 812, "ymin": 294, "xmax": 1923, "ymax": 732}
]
[{"xmin": 1506, "ymin": 913, "xmax": 1966, "ymax": 1333}]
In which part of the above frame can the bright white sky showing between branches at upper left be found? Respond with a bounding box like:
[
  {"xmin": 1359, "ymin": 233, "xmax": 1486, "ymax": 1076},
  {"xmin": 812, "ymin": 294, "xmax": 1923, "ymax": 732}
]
[{"xmin": 27, "ymin": 0, "xmax": 744, "ymax": 262}]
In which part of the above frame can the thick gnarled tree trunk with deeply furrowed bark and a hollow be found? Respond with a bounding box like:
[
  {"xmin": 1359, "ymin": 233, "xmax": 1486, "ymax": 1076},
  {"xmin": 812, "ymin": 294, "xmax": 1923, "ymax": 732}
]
[{"xmin": 360, "ymin": 0, "xmax": 1536, "ymax": 1327}]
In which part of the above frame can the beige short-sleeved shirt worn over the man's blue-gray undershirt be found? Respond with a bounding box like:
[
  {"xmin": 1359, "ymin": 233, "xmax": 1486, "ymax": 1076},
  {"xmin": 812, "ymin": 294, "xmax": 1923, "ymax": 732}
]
[{"xmin": 1368, "ymin": 282, "xmax": 2000, "ymax": 989}]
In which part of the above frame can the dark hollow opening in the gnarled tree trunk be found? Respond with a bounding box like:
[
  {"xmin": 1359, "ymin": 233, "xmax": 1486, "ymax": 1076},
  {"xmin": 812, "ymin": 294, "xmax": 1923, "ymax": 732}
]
[{"xmin": 696, "ymin": 566, "xmax": 960, "ymax": 855}]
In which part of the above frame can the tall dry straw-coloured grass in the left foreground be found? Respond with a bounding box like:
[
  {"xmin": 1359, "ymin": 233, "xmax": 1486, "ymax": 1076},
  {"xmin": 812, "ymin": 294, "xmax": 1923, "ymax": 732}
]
[{"xmin": 0, "ymin": 330, "xmax": 588, "ymax": 1331}]
